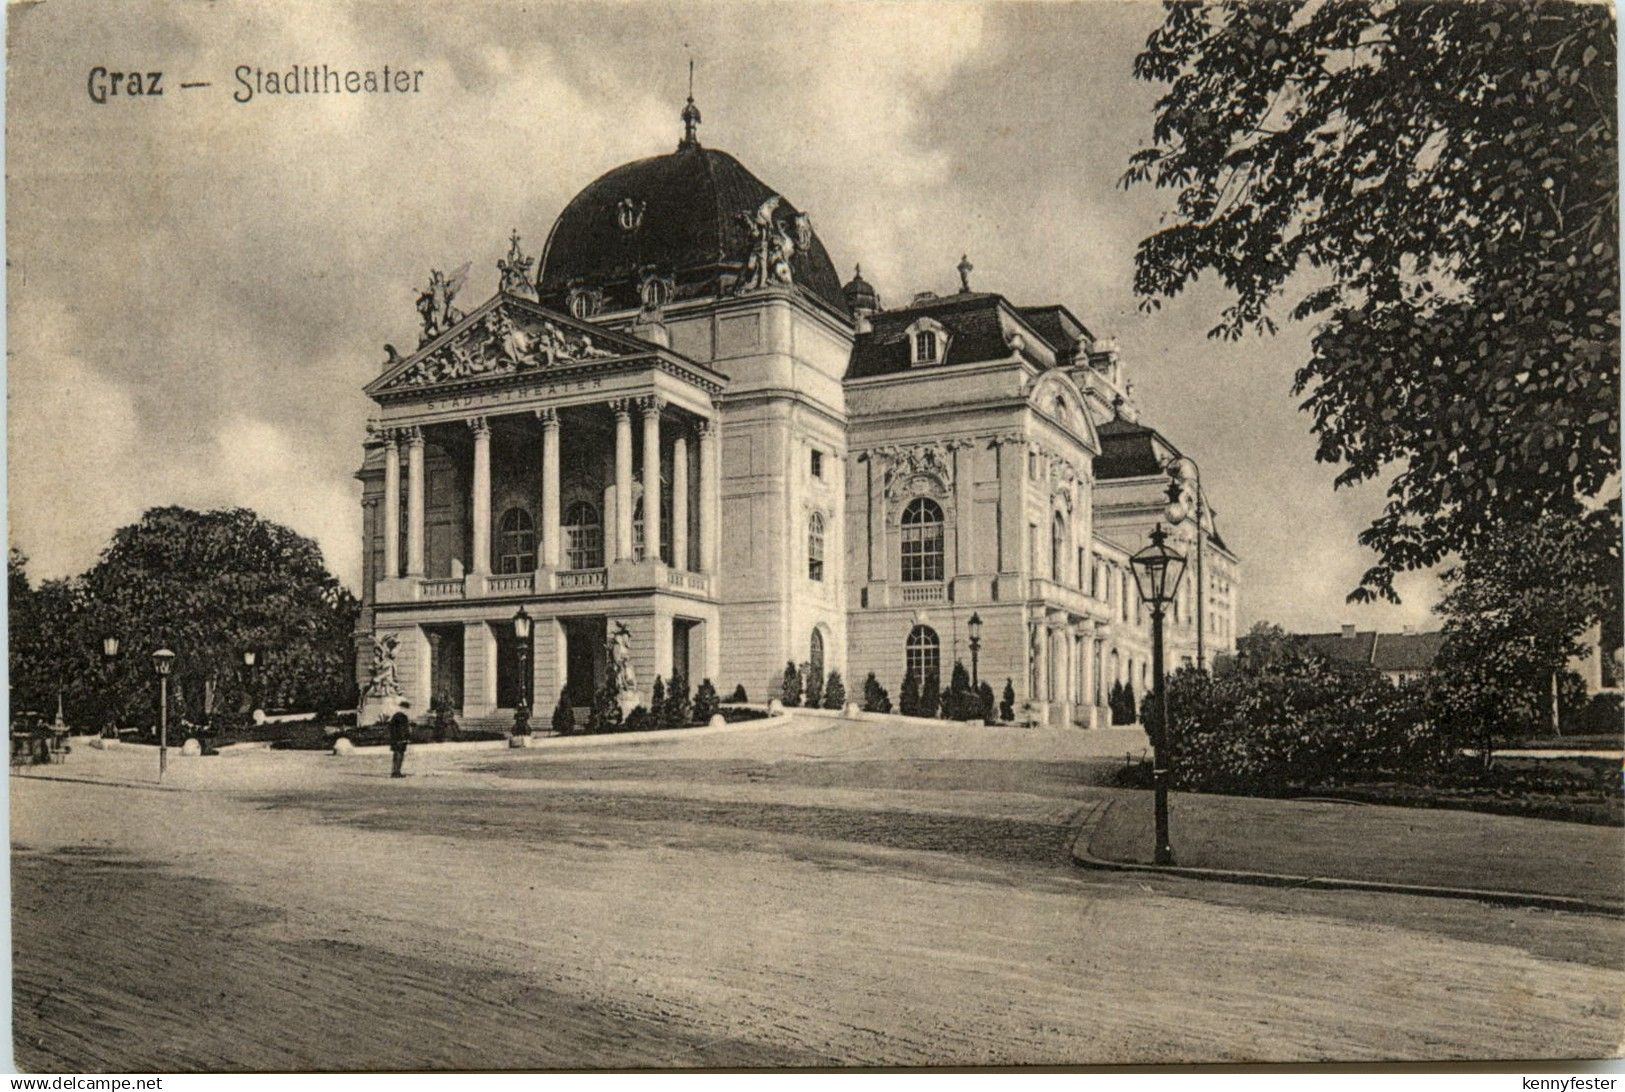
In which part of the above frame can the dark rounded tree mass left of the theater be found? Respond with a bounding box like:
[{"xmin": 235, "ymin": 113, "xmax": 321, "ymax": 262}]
[{"xmin": 7, "ymin": 507, "xmax": 358, "ymax": 725}]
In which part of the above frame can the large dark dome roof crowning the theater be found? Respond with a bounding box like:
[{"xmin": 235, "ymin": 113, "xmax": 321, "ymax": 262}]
[{"xmin": 536, "ymin": 145, "xmax": 848, "ymax": 315}]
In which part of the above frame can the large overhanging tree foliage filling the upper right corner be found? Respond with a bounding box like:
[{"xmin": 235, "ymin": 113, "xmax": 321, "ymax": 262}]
[{"xmin": 1123, "ymin": 0, "xmax": 1620, "ymax": 601}]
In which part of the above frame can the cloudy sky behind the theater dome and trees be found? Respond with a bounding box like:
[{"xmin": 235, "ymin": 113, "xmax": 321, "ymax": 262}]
[{"xmin": 7, "ymin": 0, "xmax": 1437, "ymax": 631}]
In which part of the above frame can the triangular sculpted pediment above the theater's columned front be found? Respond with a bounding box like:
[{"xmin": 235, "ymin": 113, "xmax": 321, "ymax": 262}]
[{"xmin": 366, "ymin": 293, "xmax": 658, "ymax": 397}]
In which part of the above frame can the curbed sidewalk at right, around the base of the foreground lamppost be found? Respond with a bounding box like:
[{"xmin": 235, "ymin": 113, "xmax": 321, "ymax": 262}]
[{"xmin": 1073, "ymin": 791, "xmax": 1625, "ymax": 913}]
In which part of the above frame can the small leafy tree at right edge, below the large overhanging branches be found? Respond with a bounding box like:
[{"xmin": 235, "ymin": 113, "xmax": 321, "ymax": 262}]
[{"xmin": 1433, "ymin": 515, "xmax": 1619, "ymax": 756}]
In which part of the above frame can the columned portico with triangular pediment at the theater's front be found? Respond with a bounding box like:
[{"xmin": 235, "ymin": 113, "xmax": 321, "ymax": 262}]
[{"xmin": 362, "ymin": 294, "xmax": 723, "ymax": 717}]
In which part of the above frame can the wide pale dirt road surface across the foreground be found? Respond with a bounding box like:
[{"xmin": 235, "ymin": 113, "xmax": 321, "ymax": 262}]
[{"xmin": 11, "ymin": 718, "xmax": 1625, "ymax": 1071}]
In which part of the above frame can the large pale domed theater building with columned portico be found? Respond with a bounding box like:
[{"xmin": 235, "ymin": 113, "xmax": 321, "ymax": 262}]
[{"xmin": 358, "ymin": 102, "xmax": 1240, "ymax": 726}]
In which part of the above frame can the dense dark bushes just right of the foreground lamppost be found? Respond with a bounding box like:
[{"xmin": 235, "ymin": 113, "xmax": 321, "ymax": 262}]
[{"xmin": 1149, "ymin": 650, "xmax": 1454, "ymax": 795}]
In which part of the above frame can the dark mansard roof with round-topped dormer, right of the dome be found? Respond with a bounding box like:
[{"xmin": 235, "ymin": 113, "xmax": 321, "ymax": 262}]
[{"xmin": 847, "ymin": 293, "xmax": 1058, "ymax": 379}]
